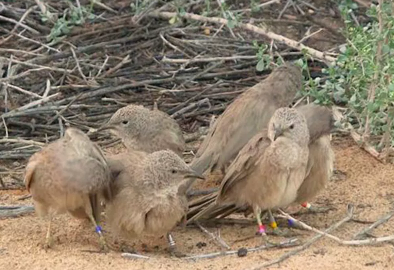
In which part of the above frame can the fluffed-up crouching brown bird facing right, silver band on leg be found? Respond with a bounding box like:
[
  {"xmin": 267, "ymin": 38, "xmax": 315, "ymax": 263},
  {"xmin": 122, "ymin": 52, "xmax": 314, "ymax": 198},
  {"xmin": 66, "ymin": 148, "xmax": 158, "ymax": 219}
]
[{"xmin": 107, "ymin": 150, "xmax": 203, "ymax": 255}]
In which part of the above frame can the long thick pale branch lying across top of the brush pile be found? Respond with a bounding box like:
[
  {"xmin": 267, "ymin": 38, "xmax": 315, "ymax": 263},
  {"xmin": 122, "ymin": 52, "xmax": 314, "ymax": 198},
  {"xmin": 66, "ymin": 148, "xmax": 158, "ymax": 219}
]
[{"xmin": 149, "ymin": 11, "xmax": 336, "ymax": 64}]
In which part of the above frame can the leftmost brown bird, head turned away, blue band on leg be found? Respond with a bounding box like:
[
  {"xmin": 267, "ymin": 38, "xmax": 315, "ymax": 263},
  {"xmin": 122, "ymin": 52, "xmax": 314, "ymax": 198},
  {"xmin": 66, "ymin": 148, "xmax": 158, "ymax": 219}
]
[{"xmin": 24, "ymin": 128, "xmax": 110, "ymax": 249}]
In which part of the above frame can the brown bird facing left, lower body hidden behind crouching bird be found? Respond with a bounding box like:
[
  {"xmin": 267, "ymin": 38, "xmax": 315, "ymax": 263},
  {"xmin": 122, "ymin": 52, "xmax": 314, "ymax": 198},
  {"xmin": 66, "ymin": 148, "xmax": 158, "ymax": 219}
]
[{"xmin": 98, "ymin": 105, "xmax": 185, "ymax": 156}]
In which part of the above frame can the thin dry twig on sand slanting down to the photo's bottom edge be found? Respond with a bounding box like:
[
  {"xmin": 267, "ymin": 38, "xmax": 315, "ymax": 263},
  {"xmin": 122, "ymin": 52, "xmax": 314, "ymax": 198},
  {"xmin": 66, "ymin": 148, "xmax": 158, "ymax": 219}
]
[{"xmin": 251, "ymin": 205, "xmax": 354, "ymax": 270}]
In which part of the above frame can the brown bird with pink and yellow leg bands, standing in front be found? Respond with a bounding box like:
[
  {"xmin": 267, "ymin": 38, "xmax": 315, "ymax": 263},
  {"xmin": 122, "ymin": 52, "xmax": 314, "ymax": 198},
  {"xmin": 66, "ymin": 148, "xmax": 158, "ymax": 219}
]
[{"xmin": 187, "ymin": 108, "xmax": 309, "ymax": 243}]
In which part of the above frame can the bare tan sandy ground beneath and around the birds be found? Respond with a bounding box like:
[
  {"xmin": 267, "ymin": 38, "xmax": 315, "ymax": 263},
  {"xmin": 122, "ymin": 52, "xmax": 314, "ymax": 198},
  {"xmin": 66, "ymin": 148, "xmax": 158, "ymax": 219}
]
[{"xmin": 0, "ymin": 138, "xmax": 394, "ymax": 270}]
